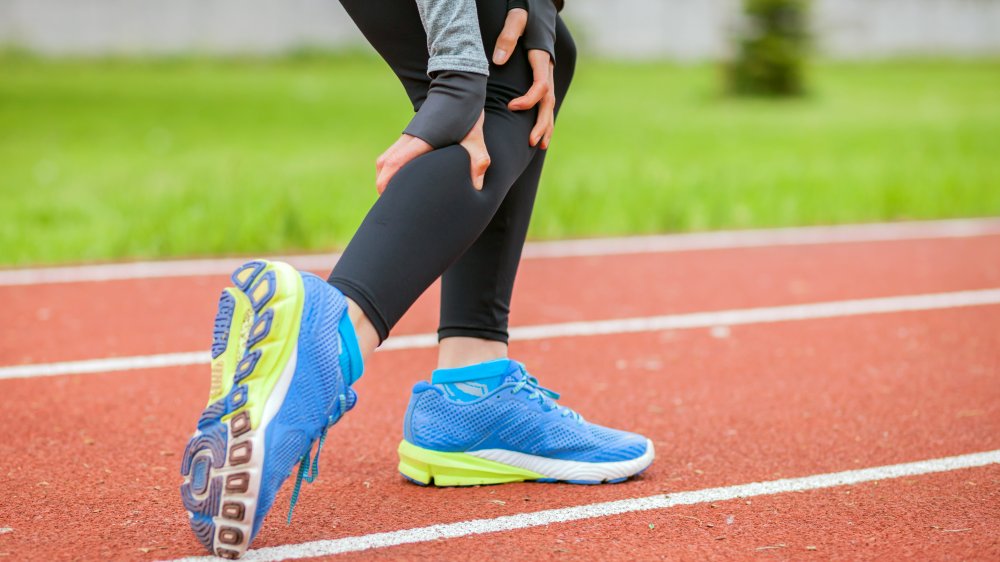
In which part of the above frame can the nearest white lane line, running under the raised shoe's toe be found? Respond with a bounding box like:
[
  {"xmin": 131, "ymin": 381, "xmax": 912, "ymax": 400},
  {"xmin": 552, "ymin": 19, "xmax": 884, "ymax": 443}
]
[{"xmin": 166, "ymin": 450, "xmax": 1000, "ymax": 562}]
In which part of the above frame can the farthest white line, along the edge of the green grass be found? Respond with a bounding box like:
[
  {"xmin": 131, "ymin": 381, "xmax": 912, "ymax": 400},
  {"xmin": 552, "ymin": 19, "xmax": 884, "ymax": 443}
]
[{"xmin": 0, "ymin": 218, "xmax": 1000, "ymax": 286}]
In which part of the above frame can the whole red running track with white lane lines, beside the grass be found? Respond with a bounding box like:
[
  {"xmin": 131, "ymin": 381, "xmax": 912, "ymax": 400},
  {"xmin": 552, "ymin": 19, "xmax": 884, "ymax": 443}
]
[{"xmin": 0, "ymin": 220, "xmax": 1000, "ymax": 560}]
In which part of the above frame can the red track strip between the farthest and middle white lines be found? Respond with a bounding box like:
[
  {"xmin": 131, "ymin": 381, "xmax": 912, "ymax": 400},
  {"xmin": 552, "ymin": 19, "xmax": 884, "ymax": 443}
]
[{"xmin": 0, "ymin": 236, "xmax": 1000, "ymax": 365}]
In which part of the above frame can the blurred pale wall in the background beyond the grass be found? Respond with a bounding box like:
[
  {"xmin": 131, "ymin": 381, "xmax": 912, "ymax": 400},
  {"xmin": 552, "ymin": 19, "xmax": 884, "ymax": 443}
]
[{"xmin": 0, "ymin": 0, "xmax": 1000, "ymax": 60}]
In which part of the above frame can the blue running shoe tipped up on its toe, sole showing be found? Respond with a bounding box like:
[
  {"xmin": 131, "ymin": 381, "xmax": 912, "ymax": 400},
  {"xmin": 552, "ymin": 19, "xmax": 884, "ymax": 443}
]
[{"xmin": 181, "ymin": 261, "xmax": 363, "ymax": 558}]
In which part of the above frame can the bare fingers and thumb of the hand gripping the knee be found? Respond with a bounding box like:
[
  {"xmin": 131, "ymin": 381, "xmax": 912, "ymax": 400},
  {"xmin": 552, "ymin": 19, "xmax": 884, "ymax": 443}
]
[{"xmin": 493, "ymin": 8, "xmax": 556, "ymax": 149}]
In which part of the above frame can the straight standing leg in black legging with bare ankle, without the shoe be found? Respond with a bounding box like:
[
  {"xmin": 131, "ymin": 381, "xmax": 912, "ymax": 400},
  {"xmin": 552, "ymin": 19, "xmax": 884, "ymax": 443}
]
[{"xmin": 438, "ymin": 16, "xmax": 576, "ymax": 368}]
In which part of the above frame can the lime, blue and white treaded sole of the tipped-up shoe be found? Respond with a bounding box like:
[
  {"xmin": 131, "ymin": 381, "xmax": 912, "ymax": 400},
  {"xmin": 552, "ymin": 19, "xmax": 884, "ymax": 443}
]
[{"xmin": 181, "ymin": 261, "xmax": 304, "ymax": 558}]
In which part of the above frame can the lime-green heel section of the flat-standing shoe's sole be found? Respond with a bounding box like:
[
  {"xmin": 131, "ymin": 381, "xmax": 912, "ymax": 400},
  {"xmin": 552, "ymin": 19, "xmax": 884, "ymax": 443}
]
[{"xmin": 398, "ymin": 439, "xmax": 545, "ymax": 486}]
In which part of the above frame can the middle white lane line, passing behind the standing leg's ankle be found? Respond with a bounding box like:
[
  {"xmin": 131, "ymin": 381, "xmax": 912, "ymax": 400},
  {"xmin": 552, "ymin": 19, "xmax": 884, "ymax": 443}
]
[{"xmin": 0, "ymin": 289, "xmax": 1000, "ymax": 380}]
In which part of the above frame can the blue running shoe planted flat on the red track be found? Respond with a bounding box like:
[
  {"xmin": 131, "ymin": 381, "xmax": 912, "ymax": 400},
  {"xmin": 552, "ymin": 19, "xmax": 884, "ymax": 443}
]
[{"xmin": 399, "ymin": 359, "xmax": 654, "ymax": 486}]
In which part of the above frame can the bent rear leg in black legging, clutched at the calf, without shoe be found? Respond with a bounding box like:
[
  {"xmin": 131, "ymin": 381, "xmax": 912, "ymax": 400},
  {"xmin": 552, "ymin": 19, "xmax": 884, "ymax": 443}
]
[{"xmin": 329, "ymin": 0, "xmax": 537, "ymax": 351}]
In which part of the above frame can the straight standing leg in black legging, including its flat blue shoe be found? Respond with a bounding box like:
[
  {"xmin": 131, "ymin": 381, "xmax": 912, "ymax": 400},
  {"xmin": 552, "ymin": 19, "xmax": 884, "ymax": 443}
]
[{"xmin": 398, "ymin": 31, "xmax": 655, "ymax": 486}]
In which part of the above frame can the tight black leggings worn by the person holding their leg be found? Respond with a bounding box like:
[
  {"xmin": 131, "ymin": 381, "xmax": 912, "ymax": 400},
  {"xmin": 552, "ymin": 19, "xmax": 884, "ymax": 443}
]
[{"xmin": 329, "ymin": 0, "xmax": 576, "ymax": 342}]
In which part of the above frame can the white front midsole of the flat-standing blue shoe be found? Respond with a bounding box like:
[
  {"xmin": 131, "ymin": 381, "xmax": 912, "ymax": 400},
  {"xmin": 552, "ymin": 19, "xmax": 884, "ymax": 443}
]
[{"xmin": 466, "ymin": 439, "xmax": 656, "ymax": 482}]
